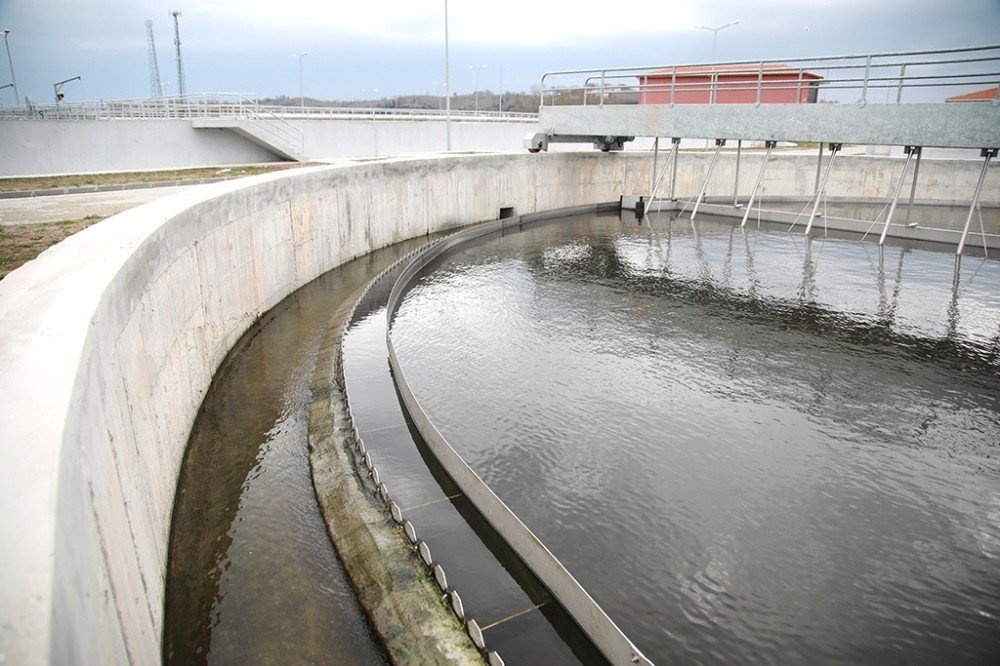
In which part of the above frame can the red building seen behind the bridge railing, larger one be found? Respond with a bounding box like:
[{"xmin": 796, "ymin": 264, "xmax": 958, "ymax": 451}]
[{"xmin": 639, "ymin": 64, "xmax": 823, "ymax": 104}]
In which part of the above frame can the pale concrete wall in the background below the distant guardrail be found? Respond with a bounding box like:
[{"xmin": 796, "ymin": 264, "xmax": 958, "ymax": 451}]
[{"xmin": 0, "ymin": 120, "xmax": 537, "ymax": 177}]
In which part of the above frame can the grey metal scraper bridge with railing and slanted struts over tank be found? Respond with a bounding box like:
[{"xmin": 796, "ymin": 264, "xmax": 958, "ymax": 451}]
[{"xmin": 525, "ymin": 45, "xmax": 1000, "ymax": 255}]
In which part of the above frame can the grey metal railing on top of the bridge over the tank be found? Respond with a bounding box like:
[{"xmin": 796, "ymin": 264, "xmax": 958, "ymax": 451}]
[{"xmin": 539, "ymin": 45, "xmax": 1000, "ymax": 107}]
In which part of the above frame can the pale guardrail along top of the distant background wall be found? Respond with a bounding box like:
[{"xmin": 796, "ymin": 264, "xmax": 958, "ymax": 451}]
[{"xmin": 0, "ymin": 93, "xmax": 538, "ymax": 122}]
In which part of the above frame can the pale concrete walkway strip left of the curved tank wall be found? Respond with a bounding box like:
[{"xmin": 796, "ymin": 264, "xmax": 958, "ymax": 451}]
[{"xmin": 0, "ymin": 185, "xmax": 200, "ymax": 227}]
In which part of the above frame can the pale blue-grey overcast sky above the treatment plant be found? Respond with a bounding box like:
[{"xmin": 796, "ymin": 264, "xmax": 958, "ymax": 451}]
[{"xmin": 0, "ymin": 0, "xmax": 1000, "ymax": 105}]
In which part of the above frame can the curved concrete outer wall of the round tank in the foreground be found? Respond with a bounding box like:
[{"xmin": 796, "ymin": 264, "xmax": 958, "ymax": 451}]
[{"xmin": 0, "ymin": 152, "xmax": 1000, "ymax": 663}]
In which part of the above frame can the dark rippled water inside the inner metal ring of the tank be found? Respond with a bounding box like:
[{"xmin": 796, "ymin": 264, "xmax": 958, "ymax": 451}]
[{"xmin": 393, "ymin": 211, "xmax": 1000, "ymax": 663}]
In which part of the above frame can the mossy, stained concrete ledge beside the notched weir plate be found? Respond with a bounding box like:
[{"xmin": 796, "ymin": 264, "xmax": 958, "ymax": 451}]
[{"xmin": 309, "ymin": 290, "xmax": 485, "ymax": 664}]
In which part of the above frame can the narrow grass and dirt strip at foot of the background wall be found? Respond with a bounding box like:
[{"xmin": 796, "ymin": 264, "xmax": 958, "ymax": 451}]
[{"xmin": 0, "ymin": 162, "xmax": 315, "ymax": 192}]
